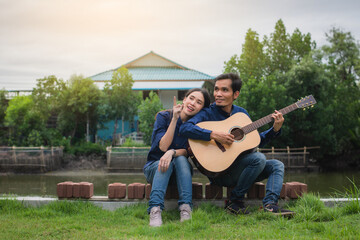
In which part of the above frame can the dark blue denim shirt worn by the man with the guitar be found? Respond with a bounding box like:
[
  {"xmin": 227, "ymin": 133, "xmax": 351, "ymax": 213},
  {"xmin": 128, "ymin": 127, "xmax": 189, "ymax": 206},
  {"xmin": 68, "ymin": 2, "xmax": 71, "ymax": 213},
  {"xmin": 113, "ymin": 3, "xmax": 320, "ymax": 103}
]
[{"xmin": 180, "ymin": 103, "xmax": 281, "ymax": 147}]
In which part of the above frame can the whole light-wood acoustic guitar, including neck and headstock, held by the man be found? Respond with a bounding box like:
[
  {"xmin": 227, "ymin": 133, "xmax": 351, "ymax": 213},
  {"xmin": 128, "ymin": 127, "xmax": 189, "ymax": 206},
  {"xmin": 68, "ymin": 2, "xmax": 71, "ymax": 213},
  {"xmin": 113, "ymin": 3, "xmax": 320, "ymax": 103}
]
[{"xmin": 189, "ymin": 95, "xmax": 316, "ymax": 177}]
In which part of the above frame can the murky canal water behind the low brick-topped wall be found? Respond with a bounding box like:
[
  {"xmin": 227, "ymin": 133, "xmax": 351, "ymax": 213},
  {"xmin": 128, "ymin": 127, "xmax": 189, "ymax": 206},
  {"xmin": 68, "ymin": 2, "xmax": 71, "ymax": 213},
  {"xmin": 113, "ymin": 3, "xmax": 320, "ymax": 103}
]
[{"xmin": 0, "ymin": 170, "xmax": 360, "ymax": 197}]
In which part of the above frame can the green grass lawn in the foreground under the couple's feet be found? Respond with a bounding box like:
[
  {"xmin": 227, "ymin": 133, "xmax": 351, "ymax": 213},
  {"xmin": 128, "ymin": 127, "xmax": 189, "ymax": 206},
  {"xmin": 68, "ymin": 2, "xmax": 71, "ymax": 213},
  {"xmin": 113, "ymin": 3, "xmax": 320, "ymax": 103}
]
[{"xmin": 0, "ymin": 194, "xmax": 360, "ymax": 239}]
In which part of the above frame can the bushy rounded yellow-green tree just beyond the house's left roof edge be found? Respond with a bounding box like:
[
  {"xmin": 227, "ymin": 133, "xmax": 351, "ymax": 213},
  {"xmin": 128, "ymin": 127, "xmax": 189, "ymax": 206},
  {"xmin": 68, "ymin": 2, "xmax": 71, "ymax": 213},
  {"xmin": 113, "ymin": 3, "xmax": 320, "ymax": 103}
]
[{"xmin": 58, "ymin": 75, "xmax": 102, "ymax": 143}]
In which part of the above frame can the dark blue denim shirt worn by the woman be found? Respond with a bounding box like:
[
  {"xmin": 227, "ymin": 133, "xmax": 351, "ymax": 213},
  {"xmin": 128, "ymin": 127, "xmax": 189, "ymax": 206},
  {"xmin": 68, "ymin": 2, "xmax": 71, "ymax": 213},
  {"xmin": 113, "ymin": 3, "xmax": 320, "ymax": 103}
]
[{"xmin": 144, "ymin": 111, "xmax": 187, "ymax": 169}]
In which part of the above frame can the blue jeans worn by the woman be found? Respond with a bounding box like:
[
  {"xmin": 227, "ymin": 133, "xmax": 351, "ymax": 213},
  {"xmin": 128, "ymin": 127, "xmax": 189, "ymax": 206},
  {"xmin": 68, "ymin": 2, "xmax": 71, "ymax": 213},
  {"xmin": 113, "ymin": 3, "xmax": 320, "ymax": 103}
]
[{"xmin": 144, "ymin": 156, "xmax": 192, "ymax": 212}]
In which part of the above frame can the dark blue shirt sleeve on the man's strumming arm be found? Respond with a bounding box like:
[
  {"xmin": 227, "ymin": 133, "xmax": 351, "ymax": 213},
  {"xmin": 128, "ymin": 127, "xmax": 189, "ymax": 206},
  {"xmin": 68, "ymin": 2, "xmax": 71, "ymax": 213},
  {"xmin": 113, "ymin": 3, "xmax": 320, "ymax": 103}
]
[{"xmin": 180, "ymin": 110, "xmax": 211, "ymax": 141}]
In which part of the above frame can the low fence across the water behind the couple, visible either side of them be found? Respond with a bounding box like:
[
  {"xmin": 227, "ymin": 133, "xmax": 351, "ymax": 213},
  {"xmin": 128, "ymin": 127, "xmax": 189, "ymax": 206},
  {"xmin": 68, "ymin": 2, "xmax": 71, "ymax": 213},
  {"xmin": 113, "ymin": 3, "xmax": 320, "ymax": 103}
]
[{"xmin": 106, "ymin": 147, "xmax": 320, "ymax": 171}]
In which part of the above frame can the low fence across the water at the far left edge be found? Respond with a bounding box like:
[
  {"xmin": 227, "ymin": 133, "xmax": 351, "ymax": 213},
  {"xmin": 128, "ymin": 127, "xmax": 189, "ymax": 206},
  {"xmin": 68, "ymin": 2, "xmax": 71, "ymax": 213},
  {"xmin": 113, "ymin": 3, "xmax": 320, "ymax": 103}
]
[{"xmin": 0, "ymin": 146, "xmax": 63, "ymax": 172}]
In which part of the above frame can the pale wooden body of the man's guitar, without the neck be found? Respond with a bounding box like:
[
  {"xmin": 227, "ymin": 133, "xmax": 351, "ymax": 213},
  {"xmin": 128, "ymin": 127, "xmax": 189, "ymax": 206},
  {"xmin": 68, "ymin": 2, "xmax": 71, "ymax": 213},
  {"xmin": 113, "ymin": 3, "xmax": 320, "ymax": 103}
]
[{"xmin": 189, "ymin": 112, "xmax": 260, "ymax": 177}]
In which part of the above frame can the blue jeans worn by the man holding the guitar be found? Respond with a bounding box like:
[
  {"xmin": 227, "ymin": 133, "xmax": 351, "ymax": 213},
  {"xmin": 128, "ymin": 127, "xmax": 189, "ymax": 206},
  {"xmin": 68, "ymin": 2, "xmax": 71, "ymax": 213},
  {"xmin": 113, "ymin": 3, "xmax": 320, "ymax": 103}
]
[{"xmin": 210, "ymin": 152, "xmax": 284, "ymax": 206}]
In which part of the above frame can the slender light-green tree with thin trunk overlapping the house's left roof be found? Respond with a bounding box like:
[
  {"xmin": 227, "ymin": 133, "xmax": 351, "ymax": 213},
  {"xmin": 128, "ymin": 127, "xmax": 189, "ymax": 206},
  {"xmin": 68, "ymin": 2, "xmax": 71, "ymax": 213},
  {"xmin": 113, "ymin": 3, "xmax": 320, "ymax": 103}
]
[{"xmin": 104, "ymin": 67, "xmax": 140, "ymax": 145}]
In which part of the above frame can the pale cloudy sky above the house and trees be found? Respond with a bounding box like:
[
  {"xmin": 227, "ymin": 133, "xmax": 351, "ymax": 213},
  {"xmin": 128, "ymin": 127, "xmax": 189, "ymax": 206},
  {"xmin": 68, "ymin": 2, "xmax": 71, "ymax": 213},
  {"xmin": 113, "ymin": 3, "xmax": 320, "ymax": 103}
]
[{"xmin": 0, "ymin": 0, "xmax": 360, "ymax": 90}]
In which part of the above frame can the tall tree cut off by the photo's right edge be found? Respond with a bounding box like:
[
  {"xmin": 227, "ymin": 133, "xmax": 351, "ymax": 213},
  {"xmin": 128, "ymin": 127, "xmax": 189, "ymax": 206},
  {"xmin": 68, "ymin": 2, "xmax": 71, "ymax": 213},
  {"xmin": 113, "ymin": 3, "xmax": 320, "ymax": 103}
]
[{"xmin": 322, "ymin": 28, "xmax": 360, "ymax": 154}]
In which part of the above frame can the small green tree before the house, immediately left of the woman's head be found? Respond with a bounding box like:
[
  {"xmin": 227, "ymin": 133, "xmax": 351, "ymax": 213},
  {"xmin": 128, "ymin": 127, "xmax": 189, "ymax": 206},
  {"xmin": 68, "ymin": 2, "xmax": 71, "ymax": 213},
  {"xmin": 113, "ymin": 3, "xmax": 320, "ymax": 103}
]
[{"xmin": 139, "ymin": 91, "xmax": 163, "ymax": 145}]
